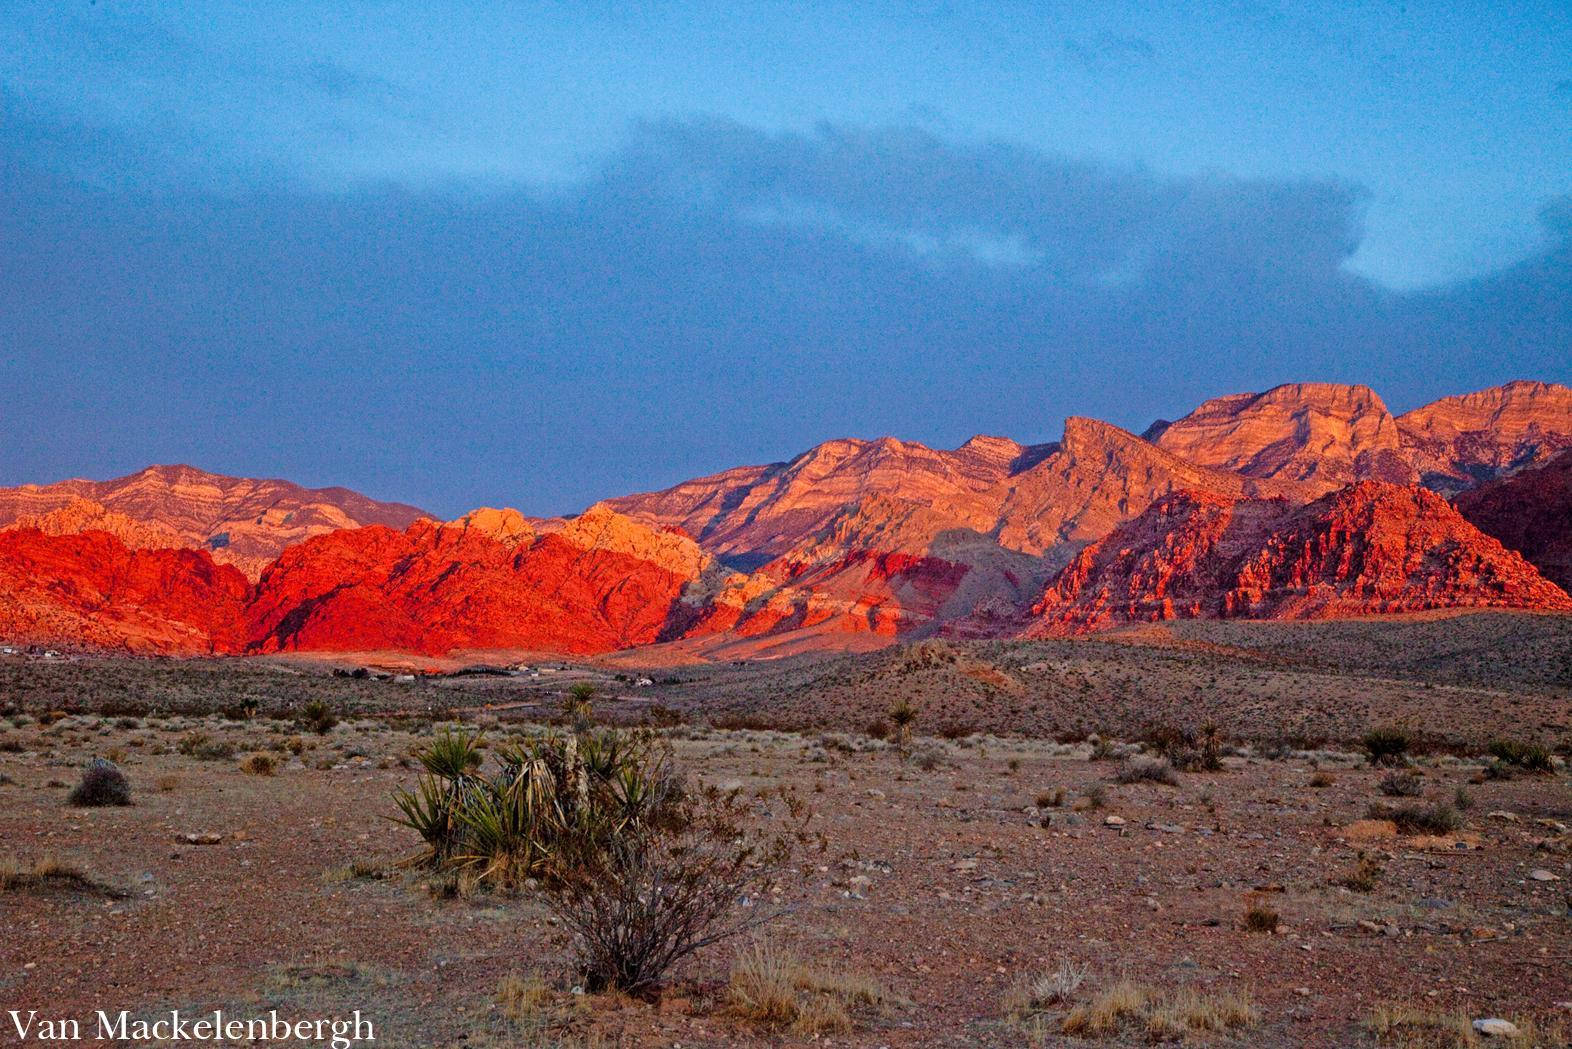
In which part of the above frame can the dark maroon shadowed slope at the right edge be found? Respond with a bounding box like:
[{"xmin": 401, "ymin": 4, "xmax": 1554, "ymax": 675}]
[{"xmin": 1456, "ymin": 451, "xmax": 1572, "ymax": 593}]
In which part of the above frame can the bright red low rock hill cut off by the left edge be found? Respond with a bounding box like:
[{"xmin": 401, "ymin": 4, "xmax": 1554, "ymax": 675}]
[{"xmin": 0, "ymin": 528, "xmax": 247, "ymax": 654}]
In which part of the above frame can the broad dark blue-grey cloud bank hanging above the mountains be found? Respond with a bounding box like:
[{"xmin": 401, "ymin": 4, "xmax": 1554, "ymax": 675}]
[{"xmin": 0, "ymin": 113, "xmax": 1572, "ymax": 513}]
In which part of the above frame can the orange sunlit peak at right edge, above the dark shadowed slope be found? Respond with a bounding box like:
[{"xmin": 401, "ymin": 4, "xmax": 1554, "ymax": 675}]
[{"xmin": 1398, "ymin": 382, "xmax": 1572, "ymax": 494}]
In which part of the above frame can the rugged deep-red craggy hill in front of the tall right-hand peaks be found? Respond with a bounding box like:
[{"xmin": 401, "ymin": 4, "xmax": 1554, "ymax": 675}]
[{"xmin": 1028, "ymin": 481, "xmax": 1572, "ymax": 635}]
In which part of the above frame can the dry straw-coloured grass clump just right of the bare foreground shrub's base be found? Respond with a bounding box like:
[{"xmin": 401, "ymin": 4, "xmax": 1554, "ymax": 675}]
[{"xmin": 726, "ymin": 940, "xmax": 898, "ymax": 1036}]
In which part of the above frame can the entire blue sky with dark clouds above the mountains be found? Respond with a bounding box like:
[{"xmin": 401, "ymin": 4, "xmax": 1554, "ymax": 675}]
[{"xmin": 0, "ymin": 0, "xmax": 1572, "ymax": 516}]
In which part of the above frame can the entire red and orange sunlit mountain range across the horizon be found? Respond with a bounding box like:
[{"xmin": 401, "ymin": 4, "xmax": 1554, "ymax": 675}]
[{"xmin": 0, "ymin": 382, "xmax": 1572, "ymax": 659}]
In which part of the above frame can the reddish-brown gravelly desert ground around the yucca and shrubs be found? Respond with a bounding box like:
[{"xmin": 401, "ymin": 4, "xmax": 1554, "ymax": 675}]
[{"xmin": 0, "ymin": 635, "xmax": 1572, "ymax": 1047}]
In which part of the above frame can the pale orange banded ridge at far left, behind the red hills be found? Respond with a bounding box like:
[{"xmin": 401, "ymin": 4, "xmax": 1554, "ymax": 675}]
[{"xmin": 0, "ymin": 466, "xmax": 426, "ymax": 579}]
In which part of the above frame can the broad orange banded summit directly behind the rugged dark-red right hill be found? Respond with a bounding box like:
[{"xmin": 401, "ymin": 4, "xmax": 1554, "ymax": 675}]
[{"xmin": 1146, "ymin": 382, "xmax": 1416, "ymax": 494}]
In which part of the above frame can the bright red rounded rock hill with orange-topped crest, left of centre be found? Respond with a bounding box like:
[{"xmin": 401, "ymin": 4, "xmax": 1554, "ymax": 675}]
[{"xmin": 248, "ymin": 506, "xmax": 711, "ymax": 653}]
